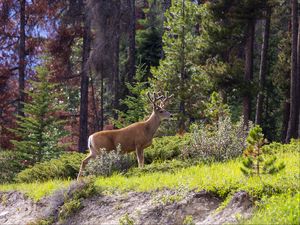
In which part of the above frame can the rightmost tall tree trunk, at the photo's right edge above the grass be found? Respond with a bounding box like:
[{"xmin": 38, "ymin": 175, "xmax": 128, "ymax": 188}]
[{"xmin": 285, "ymin": 0, "xmax": 299, "ymax": 143}]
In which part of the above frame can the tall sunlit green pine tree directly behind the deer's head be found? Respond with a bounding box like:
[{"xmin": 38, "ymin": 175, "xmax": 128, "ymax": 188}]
[{"xmin": 151, "ymin": 0, "xmax": 208, "ymax": 131}]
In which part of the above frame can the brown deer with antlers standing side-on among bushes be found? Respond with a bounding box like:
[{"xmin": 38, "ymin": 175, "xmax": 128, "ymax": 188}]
[{"xmin": 77, "ymin": 92, "xmax": 173, "ymax": 180}]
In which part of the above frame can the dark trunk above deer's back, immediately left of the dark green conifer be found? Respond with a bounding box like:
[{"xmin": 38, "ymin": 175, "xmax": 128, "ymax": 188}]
[{"xmin": 127, "ymin": 0, "xmax": 136, "ymax": 83}]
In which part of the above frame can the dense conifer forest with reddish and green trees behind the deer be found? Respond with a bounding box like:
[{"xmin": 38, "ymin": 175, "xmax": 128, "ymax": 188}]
[{"xmin": 0, "ymin": 0, "xmax": 300, "ymax": 152}]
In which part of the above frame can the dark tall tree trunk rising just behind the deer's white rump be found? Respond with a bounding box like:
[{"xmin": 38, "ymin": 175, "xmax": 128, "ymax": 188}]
[{"xmin": 78, "ymin": 3, "xmax": 91, "ymax": 152}]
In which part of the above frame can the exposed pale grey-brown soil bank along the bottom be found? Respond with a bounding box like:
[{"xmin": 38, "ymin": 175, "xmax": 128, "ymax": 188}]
[{"xmin": 0, "ymin": 184, "xmax": 252, "ymax": 225}]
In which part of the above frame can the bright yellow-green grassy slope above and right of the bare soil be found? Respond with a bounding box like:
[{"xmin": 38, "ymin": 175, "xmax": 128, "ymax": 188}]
[{"xmin": 0, "ymin": 142, "xmax": 300, "ymax": 224}]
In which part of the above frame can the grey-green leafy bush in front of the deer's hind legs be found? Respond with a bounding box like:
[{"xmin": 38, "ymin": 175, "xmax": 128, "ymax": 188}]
[{"xmin": 84, "ymin": 147, "xmax": 136, "ymax": 176}]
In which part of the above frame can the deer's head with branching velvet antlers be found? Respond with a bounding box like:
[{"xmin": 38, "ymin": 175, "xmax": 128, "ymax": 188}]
[{"xmin": 147, "ymin": 92, "xmax": 173, "ymax": 120}]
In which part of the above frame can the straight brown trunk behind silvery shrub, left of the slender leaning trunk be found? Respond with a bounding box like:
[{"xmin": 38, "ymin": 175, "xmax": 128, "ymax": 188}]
[{"xmin": 243, "ymin": 19, "xmax": 255, "ymax": 127}]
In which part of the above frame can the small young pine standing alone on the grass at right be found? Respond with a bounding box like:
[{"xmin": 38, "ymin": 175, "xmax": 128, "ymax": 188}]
[{"xmin": 241, "ymin": 125, "xmax": 285, "ymax": 176}]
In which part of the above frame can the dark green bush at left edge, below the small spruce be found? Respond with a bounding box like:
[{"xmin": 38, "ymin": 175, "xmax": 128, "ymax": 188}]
[{"xmin": 0, "ymin": 151, "xmax": 26, "ymax": 183}]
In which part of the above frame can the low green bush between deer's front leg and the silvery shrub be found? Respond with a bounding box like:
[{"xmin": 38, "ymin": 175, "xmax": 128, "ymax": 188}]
[{"xmin": 145, "ymin": 134, "xmax": 190, "ymax": 164}]
